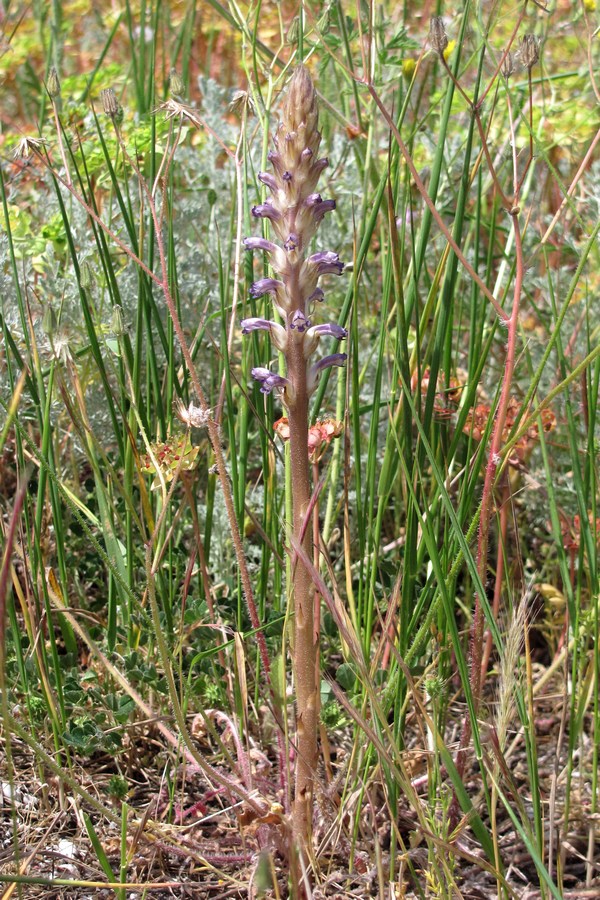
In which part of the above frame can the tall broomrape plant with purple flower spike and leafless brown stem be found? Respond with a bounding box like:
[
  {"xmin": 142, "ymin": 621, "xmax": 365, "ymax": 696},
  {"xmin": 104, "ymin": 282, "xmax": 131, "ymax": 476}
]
[{"xmin": 242, "ymin": 66, "xmax": 347, "ymax": 856}]
